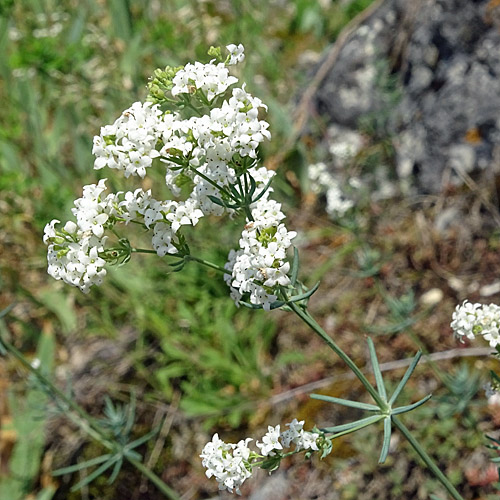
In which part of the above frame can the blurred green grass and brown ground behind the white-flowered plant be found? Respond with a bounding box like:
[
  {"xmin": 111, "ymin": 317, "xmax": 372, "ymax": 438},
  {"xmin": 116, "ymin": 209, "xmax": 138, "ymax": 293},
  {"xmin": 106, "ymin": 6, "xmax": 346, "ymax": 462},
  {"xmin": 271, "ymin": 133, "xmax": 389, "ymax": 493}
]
[{"xmin": 0, "ymin": 0, "xmax": 500, "ymax": 500}]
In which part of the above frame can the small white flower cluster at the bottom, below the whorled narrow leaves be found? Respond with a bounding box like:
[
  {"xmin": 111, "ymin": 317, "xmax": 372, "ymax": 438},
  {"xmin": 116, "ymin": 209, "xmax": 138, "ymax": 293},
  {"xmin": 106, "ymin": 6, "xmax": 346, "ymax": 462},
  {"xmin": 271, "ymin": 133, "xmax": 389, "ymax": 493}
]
[{"xmin": 200, "ymin": 419, "xmax": 320, "ymax": 495}]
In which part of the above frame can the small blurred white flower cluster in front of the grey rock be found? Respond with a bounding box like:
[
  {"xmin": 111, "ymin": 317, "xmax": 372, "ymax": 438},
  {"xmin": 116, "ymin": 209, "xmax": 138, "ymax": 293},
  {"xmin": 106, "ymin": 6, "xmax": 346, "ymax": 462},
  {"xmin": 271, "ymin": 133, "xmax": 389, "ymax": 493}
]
[{"xmin": 308, "ymin": 162, "xmax": 354, "ymax": 217}]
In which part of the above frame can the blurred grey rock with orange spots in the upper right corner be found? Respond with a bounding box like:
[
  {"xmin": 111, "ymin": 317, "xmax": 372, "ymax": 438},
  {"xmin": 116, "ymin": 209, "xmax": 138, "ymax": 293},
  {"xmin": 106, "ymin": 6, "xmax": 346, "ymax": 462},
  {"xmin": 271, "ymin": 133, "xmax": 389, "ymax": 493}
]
[{"xmin": 314, "ymin": 0, "xmax": 500, "ymax": 193}]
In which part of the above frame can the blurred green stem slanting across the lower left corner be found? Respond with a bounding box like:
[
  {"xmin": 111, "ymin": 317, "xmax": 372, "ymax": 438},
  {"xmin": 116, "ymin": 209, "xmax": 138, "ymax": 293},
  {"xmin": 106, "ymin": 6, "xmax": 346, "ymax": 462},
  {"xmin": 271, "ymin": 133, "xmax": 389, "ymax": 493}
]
[{"xmin": 0, "ymin": 338, "xmax": 180, "ymax": 500}]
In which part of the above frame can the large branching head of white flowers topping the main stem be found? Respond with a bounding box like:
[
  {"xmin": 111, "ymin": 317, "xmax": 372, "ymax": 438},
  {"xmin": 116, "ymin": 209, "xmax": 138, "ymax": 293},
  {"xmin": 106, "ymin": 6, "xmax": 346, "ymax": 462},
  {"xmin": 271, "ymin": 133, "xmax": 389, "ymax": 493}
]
[{"xmin": 45, "ymin": 44, "xmax": 296, "ymax": 300}]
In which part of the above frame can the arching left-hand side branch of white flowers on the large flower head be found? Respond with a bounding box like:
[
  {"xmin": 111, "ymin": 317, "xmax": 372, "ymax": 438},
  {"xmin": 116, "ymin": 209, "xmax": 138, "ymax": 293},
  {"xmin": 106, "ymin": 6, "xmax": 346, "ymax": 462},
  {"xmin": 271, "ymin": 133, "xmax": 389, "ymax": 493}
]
[{"xmin": 43, "ymin": 179, "xmax": 203, "ymax": 293}]
